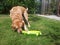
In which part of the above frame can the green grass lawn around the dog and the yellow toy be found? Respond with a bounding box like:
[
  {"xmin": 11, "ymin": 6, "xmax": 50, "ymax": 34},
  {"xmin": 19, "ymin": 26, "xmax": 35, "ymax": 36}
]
[{"xmin": 0, "ymin": 15, "xmax": 60, "ymax": 45}]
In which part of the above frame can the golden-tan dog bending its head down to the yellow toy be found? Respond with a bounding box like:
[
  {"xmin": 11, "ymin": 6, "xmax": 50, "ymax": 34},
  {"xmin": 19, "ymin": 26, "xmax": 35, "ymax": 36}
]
[{"xmin": 10, "ymin": 6, "xmax": 30, "ymax": 33}]
